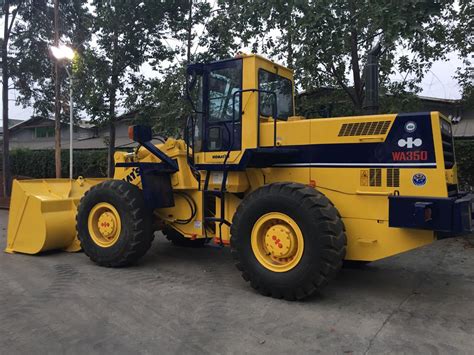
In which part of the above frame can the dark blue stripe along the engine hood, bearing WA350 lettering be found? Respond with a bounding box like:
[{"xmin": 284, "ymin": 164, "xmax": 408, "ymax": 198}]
[{"xmin": 196, "ymin": 113, "xmax": 436, "ymax": 170}]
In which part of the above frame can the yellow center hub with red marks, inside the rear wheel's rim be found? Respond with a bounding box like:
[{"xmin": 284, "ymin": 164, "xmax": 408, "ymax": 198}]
[{"xmin": 265, "ymin": 224, "xmax": 296, "ymax": 258}]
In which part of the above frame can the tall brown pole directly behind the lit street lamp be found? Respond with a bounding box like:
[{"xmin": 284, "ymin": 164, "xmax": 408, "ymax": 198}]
[{"xmin": 54, "ymin": 0, "xmax": 61, "ymax": 178}]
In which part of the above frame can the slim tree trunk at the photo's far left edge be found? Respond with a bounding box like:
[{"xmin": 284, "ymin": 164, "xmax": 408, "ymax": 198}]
[{"xmin": 2, "ymin": 0, "xmax": 11, "ymax": 197}]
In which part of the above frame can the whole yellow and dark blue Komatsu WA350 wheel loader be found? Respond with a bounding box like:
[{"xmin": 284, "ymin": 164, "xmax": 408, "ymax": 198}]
[{"xmin": 6, "ymin": 55, "xmax": 473, "ymax": 300}]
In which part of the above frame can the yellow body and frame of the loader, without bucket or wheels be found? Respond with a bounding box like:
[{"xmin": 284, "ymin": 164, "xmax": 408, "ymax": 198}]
[{"xmin": 110, "ymin": 55, "xmax": 457, "ymax": 261}]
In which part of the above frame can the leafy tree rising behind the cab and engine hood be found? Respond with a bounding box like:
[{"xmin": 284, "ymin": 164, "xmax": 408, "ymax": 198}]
[{"xmin": 207, "ymin": 0, "xmax": 458, "ymax": 113}]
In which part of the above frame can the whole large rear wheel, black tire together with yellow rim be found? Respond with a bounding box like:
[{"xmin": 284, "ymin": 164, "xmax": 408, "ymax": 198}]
[{"xmin": 231, "ymin": 183, "xmax": 347, "ymax": 300}]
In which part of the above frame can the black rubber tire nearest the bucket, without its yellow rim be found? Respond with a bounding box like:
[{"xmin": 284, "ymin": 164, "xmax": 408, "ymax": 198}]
[{"xmin": 76, "ymin": 180, "xmax": 153, "ymax": 267}]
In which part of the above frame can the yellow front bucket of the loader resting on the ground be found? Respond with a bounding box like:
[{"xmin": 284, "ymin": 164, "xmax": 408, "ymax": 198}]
[{"xmin": 5, "ymin": 178, "xmax": 105, "ymax": 254}]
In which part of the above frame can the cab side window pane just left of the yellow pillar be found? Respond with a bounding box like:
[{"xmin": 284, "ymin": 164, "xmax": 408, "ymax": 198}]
[{"xmin": 209, "ymin": 61, "xmax": 242, "ymax": 122}]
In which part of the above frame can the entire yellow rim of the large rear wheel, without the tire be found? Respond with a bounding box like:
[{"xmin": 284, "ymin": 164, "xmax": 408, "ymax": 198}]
[{"xmin": 251, "ymin": 212, "xmax": 304, "ymax": 272}]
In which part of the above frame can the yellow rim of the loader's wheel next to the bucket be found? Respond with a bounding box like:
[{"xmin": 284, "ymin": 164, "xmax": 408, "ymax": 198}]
[{"xmin": 87, "ymin": 202, "xmax": 122, "ymax": 248}]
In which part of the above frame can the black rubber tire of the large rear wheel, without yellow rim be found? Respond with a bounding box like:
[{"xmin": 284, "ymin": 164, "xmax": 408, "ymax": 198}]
[{"xmin": 230, "ymin": 183, "xmax": 347, "ymax": 301}]
